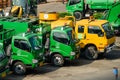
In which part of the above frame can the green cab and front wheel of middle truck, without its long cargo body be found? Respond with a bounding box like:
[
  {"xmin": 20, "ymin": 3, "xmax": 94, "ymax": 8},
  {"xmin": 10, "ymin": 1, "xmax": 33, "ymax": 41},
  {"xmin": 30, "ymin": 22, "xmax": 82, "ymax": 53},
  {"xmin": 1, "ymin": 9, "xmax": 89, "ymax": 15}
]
[{"xmin": 38, "ymin": 24, "xmax": 80, "ymax": 66}]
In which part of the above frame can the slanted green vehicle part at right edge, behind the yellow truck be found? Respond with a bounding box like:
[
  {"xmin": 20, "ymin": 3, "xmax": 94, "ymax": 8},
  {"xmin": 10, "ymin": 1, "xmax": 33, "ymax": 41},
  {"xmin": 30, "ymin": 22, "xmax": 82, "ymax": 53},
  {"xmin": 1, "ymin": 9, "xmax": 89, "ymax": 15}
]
[{"xmin": 104, "ymin": 2, "xmax": 120, "ymax": 35}]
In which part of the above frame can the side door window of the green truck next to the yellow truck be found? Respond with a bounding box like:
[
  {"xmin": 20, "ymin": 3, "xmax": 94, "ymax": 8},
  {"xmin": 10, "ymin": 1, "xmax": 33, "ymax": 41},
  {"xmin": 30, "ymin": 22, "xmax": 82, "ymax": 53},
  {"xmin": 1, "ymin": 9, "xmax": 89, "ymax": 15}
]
[{"xmin": 53, "ymin": 32, "xmax": 69, "ymax": 44}]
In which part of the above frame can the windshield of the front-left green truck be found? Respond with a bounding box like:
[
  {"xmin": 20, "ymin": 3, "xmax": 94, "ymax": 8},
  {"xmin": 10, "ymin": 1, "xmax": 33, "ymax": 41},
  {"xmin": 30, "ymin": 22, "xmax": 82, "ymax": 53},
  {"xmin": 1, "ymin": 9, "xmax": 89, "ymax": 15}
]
[{"xmin": 29, "ymin": 36, "xmax": 41, "ymax": 49}]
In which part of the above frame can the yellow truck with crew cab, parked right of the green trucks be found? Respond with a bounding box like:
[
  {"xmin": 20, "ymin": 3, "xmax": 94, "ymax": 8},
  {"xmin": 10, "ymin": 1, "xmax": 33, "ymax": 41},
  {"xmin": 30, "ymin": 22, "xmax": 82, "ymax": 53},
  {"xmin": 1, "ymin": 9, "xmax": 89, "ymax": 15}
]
[{"xmin": 40, "ymin": 13, "xmax": 115, "ymax": 60}]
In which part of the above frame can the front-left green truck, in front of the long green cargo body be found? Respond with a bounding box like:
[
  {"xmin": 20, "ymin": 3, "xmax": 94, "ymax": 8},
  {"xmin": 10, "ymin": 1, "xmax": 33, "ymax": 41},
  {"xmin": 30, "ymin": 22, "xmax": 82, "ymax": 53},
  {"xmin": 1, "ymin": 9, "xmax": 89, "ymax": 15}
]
[{"xmin": 0, "ymin": 23, "xmax": 44, "ymax": 75}]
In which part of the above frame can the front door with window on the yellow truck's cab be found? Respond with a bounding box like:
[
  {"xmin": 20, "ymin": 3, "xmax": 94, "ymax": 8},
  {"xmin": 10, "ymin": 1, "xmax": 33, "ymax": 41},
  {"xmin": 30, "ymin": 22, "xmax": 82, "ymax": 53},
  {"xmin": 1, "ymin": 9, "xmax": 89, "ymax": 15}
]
[{"xmin": 86, "ymin": 25, "xmax": 104, "ymax": 46}]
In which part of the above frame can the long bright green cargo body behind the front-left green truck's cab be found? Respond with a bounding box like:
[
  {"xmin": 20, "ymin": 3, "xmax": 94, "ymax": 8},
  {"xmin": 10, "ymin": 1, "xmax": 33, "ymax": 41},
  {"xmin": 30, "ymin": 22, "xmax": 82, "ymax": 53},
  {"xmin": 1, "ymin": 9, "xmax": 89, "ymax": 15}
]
[{"xmin": 0, "ymin": 17, "xmax": 38, "ymax": 34}]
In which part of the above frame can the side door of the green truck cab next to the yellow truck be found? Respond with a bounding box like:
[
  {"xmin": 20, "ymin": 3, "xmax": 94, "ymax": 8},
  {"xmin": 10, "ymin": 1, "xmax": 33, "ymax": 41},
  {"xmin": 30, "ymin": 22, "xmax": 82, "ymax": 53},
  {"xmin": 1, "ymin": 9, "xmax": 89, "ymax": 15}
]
[{"xmin": 50, "ymin": 32, "xmax": 71, "ymax": 56}]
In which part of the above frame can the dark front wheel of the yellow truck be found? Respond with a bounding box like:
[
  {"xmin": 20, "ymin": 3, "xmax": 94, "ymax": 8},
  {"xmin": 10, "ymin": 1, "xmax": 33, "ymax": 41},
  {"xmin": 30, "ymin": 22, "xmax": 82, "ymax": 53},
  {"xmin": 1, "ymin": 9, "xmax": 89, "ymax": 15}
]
[{"xmin": 85, "ymin": 46, "xmax": 98, "ymax": 60}]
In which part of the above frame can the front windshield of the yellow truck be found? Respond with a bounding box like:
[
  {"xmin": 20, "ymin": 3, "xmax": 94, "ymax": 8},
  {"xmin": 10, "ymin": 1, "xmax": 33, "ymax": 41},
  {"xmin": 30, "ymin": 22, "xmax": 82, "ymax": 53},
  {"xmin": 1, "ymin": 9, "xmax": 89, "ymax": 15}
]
[{"xmin": 102, "ymin": 22, "xmax": 114, "ymax": 39}]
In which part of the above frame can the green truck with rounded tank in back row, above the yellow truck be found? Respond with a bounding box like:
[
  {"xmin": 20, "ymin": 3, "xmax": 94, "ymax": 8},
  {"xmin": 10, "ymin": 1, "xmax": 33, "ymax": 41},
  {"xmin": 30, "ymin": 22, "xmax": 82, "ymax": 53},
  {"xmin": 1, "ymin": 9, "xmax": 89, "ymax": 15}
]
[{"xmin": 66, "ymin": 0, "xmax": 120, "ymax": 20}]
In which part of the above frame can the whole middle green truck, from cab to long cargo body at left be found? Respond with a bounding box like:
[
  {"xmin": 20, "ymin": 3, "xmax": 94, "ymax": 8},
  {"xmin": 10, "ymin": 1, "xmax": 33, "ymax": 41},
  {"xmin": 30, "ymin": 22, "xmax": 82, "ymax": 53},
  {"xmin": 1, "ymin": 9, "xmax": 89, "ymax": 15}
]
[{"xmin": 0, "ymin": 17, "xmax": 79, "ymax": 66}]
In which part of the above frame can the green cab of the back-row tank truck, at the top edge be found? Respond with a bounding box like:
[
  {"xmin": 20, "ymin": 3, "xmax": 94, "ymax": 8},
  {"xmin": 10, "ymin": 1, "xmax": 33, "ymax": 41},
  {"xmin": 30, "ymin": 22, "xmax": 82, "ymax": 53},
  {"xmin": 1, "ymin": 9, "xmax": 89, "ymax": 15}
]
[{"xmin": 66, "ymin": 0, "xmax": 84, "ymax": 12}]
